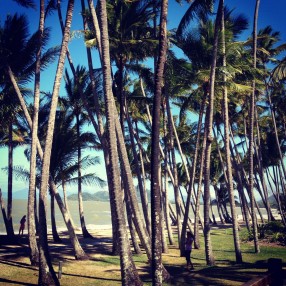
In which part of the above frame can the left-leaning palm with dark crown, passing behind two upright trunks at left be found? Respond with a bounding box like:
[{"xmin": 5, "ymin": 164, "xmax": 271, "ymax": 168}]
[{"xmin": 0, "ymin": 12, "xmax": 87, "ymax": 264}]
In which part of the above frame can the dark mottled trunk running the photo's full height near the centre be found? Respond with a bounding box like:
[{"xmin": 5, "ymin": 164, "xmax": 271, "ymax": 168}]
[{"xmin": 151, "ymin": 0, "xmax": 168, "ymax": 285}]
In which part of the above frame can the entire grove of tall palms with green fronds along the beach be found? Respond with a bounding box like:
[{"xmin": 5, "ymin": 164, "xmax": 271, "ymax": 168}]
[{"xmin": 0, "ymin": 0, "xmax": 286, "ymax": 285}]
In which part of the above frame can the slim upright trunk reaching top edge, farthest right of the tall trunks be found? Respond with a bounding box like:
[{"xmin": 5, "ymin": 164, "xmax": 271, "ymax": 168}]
[{"xmin": 248, "ymin": 0, "xmax": 260, "ymax": 253}]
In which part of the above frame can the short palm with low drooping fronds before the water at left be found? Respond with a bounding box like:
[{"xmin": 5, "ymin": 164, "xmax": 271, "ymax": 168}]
[{"xmin": 50, "ymin": 107, "xmax": 104, "ymax": 239}]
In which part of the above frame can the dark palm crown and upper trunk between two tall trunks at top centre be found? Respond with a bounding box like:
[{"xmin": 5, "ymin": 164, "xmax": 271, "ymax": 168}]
[{"xmin": 103, "ymin": 0, "xmax": 155, "ymax": 129}]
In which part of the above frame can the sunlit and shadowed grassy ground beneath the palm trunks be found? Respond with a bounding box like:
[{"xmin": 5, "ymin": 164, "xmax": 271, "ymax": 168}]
[{"xmin": 0, "ymin": 226, "xmax": 286, "ymax": 285}]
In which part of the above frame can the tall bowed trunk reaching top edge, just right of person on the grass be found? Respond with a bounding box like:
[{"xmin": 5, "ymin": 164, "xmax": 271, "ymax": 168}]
[{"xmin": 204, "ymin": 0, "xmax": 223, "ymax": 265}]
